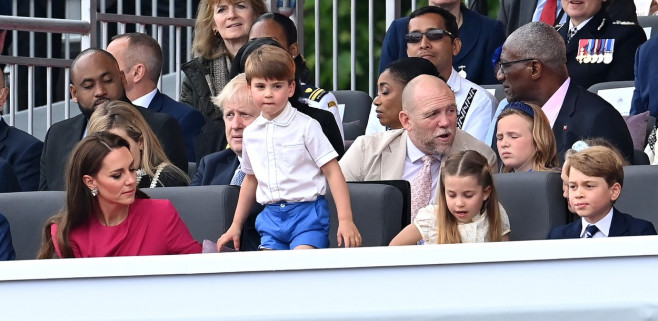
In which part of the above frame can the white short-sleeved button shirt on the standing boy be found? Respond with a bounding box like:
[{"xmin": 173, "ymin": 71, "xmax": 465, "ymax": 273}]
[{"xmin": 242, "ymin": 103, "xmax": 338, "ymax": 205}]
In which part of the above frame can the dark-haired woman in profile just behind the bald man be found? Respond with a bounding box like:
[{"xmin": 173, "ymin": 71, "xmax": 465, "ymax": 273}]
[{"xmin": 368, "ymin": 57, "xmax": 445, "ymax": 129}]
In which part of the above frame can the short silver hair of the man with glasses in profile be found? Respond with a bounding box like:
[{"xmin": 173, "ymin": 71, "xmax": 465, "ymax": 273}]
[{"xmin": 504, "ymin": 22, "xmax": 567, "ymax": 70}]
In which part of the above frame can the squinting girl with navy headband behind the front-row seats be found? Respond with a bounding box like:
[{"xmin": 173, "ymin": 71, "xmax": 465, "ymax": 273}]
[{"xmin": 496, "ymin": 102, "xmax": 558, "ymax": 173}]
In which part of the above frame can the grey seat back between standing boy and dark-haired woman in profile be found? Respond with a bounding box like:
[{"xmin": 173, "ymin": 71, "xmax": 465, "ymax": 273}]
[{"xmin": 331, "ymin": 90, "xmax": 372, "ymax": 140}]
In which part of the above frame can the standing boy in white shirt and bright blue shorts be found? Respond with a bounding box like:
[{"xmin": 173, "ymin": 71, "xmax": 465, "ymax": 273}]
[{"xmin": 217, "ymin": 45, "xmax": 362, "ymax": 251}]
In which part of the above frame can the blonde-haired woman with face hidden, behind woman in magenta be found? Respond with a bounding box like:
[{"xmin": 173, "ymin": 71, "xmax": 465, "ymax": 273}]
[{"xmin": 88, "ymin": 100, "xmax": 190, "ymax": 188}]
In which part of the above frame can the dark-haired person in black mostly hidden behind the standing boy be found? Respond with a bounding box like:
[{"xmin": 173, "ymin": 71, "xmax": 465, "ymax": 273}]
[{"xmin": 231, "ymin": 38, "xmax": 345, "ymax": 159}]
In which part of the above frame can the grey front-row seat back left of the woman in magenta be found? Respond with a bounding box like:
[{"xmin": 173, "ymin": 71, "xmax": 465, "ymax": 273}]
[{"xmin": 0, "ymin": 191, "xmax": 65, "ymax": 260}]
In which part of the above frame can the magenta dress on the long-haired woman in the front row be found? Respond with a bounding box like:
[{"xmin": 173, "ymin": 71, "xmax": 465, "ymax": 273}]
[{"xmin": 50, "ymin": 199, "xmax": 201, "ymax": 257}]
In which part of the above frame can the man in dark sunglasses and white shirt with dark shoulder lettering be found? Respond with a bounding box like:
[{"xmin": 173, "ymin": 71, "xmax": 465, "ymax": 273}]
[{"xmin": 405, "ymin": 6, "xmax": 498, "ymax": 141}]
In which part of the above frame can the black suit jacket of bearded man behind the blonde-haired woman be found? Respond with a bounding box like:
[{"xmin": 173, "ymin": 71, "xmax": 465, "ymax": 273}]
[{"xmin": 39, "ymin": 107, "xmax": 187, "ymax": 191}]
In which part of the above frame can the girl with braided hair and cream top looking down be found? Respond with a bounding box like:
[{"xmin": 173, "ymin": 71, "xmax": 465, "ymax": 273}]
[{"xmin": 390, "ymin": 150, "xmax": 510, "ymax": 245}]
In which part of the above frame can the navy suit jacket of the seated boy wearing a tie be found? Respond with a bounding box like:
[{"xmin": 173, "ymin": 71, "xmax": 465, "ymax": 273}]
[{"xmin": 546, "ymin": 208, "xmax": 656, "ymax": 239}]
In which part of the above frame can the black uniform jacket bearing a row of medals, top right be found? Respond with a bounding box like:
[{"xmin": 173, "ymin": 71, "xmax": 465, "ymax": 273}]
[{"xmin": 558, "ymin": 10, "xmax": 647, "ymax": 88}]
